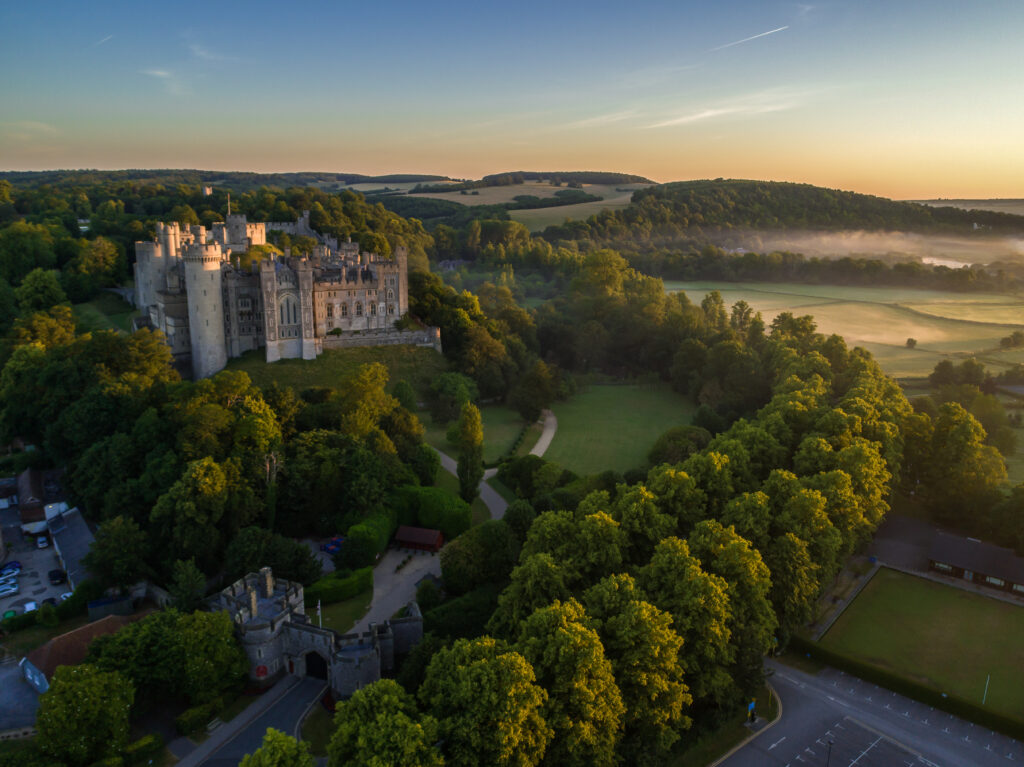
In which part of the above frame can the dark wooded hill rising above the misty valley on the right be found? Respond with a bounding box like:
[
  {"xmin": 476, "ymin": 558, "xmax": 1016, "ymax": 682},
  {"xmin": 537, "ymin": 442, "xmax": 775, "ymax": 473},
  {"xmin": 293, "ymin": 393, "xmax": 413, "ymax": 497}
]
[{"xmin": 544, "ymin": 179, "xmax": 1024, "ymax": 241}]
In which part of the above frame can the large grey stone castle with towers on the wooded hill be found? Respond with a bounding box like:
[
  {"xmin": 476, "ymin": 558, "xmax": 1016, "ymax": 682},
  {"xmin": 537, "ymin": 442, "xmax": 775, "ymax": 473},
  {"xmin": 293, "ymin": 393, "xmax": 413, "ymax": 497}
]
[{"xmin": 134, "ymin": 211, "xmax": 440, "ymax": 379}]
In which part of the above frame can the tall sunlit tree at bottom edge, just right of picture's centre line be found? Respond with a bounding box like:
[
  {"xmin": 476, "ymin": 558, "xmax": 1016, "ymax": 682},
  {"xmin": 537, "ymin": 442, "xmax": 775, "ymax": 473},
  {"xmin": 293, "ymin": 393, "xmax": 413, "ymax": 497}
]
[{"xmin": 516, "ymin": 599, "xmax": 626, "ymax": 765}]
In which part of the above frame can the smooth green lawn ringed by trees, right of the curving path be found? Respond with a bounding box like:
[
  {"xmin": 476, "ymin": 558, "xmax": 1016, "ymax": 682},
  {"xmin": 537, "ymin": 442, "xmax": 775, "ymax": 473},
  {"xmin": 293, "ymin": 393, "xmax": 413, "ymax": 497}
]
[{"xmin": 544, "ymin": 384, "xmax": 694, "ymax": 474}]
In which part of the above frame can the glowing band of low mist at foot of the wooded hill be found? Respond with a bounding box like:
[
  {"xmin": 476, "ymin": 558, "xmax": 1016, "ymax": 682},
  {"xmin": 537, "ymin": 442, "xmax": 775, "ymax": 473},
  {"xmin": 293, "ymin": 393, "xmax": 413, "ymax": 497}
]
[{"xmin": 719, "ymin": 230, "xmax": 1024, "ymax": 267}]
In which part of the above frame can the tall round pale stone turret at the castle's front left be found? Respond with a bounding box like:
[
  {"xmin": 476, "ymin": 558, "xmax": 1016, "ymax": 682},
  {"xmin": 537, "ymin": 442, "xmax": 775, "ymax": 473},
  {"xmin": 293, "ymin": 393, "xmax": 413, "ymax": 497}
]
[{"xmin": 184, "ymin": 242, "xmax": 227, "ymax": 379}]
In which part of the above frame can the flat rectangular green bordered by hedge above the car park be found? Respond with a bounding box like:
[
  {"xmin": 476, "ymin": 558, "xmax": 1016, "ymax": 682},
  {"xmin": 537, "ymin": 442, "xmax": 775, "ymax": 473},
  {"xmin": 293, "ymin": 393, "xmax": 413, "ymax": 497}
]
[{"xmin": 821, "ymin": 568, "xmax": 1024, "ymax": 717}]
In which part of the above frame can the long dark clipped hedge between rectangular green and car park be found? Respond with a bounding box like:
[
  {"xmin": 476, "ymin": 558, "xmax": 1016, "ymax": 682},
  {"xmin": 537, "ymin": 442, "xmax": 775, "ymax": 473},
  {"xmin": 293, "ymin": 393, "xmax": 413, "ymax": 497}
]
[{"xmin": 790, "ymin": 637, "xmax": 1024, "ymax": 739}]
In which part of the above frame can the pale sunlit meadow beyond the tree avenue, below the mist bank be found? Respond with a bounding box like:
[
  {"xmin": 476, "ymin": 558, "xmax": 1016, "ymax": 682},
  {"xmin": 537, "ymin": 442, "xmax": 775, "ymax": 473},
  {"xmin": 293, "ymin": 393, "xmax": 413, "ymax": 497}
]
[{"xmin": 665, "ymin": 281, "xmax": 1024, "ymax": 377}]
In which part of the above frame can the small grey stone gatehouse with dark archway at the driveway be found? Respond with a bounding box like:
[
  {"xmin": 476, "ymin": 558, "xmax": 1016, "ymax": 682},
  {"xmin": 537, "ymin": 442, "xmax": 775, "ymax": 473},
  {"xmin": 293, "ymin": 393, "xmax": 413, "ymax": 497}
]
[{"xmin": 210, "ymin": 567, "xmax": 423, "ymax": 700}]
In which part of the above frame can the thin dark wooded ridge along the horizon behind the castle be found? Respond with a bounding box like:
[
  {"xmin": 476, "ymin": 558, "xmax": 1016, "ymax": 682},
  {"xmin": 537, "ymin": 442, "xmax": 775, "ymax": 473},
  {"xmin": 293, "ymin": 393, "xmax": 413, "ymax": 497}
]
[{"xmin": 0, "ymin": 169, "xmax": 447, "ymax": 191}]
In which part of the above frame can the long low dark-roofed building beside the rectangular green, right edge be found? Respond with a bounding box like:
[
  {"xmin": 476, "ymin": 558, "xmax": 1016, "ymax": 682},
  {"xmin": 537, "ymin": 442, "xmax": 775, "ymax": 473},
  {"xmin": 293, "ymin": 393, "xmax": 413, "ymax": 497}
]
[{"xmin": 928, "ymin": 530, "xmax": 1024, "ymax": 596}]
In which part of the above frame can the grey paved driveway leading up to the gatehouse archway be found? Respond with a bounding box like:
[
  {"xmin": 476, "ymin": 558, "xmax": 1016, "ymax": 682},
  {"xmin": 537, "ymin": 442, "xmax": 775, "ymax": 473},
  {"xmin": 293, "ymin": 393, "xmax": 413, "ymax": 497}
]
[{"xmin": 176, "ymin": 676, "xmax": 327, "ymax": 767}]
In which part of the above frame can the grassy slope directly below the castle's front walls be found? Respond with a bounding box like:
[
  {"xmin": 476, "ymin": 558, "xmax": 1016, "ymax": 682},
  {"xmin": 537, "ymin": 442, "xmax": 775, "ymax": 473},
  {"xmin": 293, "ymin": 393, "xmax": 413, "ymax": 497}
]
[{"xmin": 227, "ymin": 346, "xmax": 447, "ymax": 392}]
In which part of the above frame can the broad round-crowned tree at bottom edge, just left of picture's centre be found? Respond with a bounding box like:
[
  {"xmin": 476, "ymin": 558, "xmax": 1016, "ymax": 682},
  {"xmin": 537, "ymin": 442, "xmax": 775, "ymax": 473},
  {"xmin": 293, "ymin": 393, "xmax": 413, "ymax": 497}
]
[{"xmin": 419, "ymin": 637, "xmax": 553, "ymax": 767}]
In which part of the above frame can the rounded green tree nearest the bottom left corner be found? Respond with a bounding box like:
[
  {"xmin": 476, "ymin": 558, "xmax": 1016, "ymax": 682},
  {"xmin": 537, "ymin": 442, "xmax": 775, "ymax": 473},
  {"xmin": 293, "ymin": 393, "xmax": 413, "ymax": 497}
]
[{"xmin": 36, "ymin": 664, "xmax": 135, "ymax": 765}]
